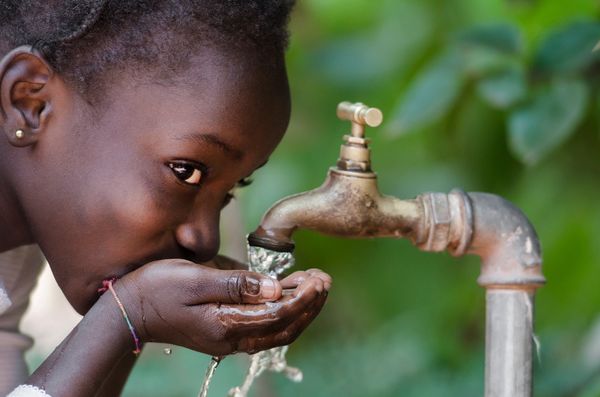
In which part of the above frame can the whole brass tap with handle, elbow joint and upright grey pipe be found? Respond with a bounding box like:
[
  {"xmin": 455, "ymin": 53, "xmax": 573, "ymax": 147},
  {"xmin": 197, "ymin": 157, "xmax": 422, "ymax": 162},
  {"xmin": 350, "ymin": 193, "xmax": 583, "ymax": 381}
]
[{"xmin": 248, "ymin": 102, "xmax": 545, "ymax": 397}]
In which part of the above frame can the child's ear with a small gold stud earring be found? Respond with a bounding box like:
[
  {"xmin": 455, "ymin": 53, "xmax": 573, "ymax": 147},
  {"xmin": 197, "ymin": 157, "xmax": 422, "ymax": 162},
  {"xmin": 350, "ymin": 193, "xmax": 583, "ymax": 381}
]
[{"xmin": 0, "ymin": 46, "xmax": 54, "ymax": 146}]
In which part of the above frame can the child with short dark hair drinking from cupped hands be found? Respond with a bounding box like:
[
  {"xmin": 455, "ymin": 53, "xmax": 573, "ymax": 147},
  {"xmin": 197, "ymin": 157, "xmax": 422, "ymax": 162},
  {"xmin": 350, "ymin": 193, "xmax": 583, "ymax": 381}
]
[{"xmin": 0, "ymin": 0, "xmax": 331, "ymax": 397}]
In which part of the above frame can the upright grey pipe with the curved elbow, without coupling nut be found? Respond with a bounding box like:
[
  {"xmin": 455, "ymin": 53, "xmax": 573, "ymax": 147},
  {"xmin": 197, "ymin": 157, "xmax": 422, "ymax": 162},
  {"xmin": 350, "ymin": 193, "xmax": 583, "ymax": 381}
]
[{"xmin": 468, "ymin": 193, "xmax": 545, "ymax": 397}]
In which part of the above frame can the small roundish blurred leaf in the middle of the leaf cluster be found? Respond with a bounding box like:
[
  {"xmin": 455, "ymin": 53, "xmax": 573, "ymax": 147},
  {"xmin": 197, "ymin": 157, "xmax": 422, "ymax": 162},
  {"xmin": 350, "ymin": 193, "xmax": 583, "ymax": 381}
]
[{"xmin": 477, "ymin": 68, "xmax": 527, "ymax": 109}]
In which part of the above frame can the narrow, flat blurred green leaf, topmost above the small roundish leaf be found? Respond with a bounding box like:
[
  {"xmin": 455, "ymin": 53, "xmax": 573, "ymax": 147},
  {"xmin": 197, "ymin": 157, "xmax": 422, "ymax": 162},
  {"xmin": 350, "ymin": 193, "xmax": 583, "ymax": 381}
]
[{"xmin": 458, "ymin": 24, "xmax": 523, "ymax": 54}]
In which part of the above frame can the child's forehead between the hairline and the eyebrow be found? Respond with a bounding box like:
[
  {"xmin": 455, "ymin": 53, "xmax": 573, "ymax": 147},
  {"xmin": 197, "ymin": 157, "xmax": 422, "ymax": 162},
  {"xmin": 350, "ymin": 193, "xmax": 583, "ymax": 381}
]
[{"xmin": 92, "ymin": 50, "xmax": 290, "ymax": 153}]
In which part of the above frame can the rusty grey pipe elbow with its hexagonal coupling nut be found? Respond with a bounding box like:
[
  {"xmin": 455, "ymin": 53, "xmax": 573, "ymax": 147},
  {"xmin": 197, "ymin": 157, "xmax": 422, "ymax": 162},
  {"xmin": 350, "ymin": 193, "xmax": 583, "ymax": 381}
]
[{"xmin": 416, "ymin": 190, "xmax": 545, "ymax": 288}]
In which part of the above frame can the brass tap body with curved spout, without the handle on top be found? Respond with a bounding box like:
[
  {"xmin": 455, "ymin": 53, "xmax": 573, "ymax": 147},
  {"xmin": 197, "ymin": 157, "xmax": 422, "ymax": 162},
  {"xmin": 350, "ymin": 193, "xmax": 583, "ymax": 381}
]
[{"xmin": 248, "ymin": 168, "xmax": 423, "ymax": 251}]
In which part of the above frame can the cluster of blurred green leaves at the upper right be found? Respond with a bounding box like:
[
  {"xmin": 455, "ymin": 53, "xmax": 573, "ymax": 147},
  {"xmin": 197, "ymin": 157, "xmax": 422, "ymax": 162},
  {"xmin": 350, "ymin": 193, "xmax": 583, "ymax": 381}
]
[{"xmin": 391, "ymin": 15, "xmax": 600, "ymax": 164}]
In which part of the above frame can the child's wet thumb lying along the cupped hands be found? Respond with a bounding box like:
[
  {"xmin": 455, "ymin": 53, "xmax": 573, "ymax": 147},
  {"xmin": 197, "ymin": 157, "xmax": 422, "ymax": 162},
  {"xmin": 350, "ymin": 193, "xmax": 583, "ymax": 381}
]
[{"xmin": 186, "ymin": 268, "xmax": 282, "ymax": 304}]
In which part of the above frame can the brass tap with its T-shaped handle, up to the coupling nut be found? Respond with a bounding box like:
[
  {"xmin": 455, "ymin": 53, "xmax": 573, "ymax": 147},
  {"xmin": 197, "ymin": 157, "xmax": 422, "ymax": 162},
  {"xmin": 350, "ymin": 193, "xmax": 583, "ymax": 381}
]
[{"xmin": 248, "ymin": 102, "xmax": 422, "ymax": 251}]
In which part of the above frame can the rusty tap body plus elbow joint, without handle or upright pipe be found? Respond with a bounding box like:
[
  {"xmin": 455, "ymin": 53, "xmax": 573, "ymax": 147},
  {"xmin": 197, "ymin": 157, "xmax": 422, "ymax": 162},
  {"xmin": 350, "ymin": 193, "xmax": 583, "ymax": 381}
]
[{"xmin": 248, "ymin": 187, "xmax": 545, "ymax": 289}]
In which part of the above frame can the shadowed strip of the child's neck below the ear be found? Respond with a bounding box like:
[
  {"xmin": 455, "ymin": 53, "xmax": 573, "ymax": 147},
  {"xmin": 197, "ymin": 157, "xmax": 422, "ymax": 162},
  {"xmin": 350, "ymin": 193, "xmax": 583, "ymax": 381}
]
[{"xmin": 0, "ymin": 145, "xmax": 33, "ymax": 252}]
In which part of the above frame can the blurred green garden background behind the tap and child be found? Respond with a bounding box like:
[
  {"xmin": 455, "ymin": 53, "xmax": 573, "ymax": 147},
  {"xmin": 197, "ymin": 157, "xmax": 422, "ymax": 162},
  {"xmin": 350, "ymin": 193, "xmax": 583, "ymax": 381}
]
[{"xmin": 126, "ymin": 0, "xmax": 600, "ymax": 397}]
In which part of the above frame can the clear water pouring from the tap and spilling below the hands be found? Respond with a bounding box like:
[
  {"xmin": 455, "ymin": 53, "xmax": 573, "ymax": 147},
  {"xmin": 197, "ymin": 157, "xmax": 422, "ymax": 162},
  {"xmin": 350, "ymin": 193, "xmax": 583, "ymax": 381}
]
[{"xmin": 198, "ymin": 245, "xmax": 302, "ymax": 397}]
